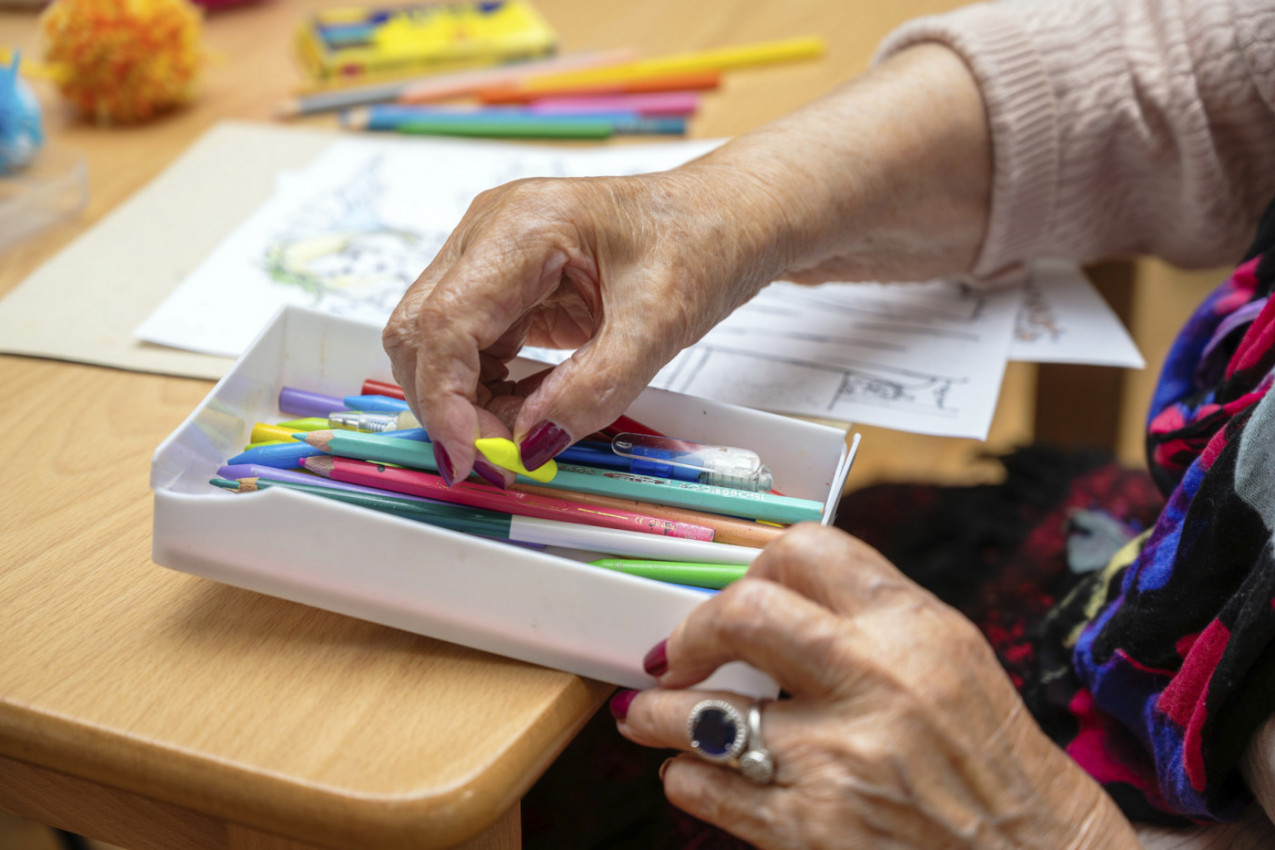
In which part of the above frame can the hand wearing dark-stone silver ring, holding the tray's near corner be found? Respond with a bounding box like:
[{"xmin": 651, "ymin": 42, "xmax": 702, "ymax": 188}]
[{"xmin": 612, "ymin": 526, "xmax": 1139, "ymax": 850}]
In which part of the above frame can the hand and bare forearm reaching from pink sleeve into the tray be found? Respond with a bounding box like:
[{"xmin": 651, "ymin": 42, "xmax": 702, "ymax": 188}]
[{"xmin": 385, "ymin": 45, "xmax": 991, "ymax": 483}]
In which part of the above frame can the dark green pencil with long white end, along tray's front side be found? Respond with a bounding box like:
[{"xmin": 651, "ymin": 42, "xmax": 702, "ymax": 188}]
[{"xmin": 209, "ymin": 478, "xmax": 757, "ymax": 563}]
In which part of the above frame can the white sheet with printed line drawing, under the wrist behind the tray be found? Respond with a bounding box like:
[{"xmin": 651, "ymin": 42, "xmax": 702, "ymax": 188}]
[{"xmin": 523, "ymin": 282, "xmax": 1023, "ymax": 438}]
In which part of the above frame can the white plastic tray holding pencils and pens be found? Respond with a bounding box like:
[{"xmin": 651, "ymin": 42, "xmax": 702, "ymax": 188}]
[{"xmin": 150, "ymin": 307, "xmax": 853, "ymax": 696}]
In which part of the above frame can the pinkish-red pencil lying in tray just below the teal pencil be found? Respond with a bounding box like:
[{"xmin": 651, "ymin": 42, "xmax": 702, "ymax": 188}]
[{"xmin": 301, "ymin": 456, "xmax": 713, "ymax": 540}]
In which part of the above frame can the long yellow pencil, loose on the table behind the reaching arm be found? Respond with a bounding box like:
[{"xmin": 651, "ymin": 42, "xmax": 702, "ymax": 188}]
[{"xmin": 521, "ymin": 36, "xmax": 824, "ymax": 89}]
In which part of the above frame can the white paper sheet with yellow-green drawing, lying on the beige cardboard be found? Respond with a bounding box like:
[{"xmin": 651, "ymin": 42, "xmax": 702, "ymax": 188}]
[{"xmin": 136, "ymin": 139, "xmax": 719, "ymax": 357}]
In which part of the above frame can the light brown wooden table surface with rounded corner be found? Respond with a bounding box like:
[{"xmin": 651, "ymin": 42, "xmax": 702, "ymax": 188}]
[{"xmin": 0, "ymin": 0, "xmax": 974, "ymax": 849}]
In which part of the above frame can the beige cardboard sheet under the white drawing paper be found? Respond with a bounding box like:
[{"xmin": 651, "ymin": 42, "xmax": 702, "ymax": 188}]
[{"xmin": 0, "ymin": 122, "xmax": 338, "ymax": 378}]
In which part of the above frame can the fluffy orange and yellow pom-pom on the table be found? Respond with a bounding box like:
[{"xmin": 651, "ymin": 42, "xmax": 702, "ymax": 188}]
[{"xmin": 41, "ymin": 0, "xmax": 203, "ymax": 124}]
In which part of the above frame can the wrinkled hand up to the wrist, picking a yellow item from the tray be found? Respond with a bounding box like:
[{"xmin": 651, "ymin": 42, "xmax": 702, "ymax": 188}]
[{"xmin": 384, "ymin": 163, "xmax": 782, "ymax": 480}]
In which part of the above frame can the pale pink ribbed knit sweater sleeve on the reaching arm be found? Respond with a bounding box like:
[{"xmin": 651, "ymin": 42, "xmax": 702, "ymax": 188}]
[{"xmin": 878, "ymin": 0, "xmax": 1275, "ymax": 277}]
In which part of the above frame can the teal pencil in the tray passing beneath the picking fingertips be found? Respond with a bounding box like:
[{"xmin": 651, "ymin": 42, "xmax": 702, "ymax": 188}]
[{"xmin": 297, "ymin": 431, "xmax": 824, "ymax": 522}]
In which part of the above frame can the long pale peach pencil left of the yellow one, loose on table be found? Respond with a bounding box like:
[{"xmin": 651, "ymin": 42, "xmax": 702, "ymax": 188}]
[{"xmin": 274, "ymin": 51, "xmax": 632, "ymax": 119}]
